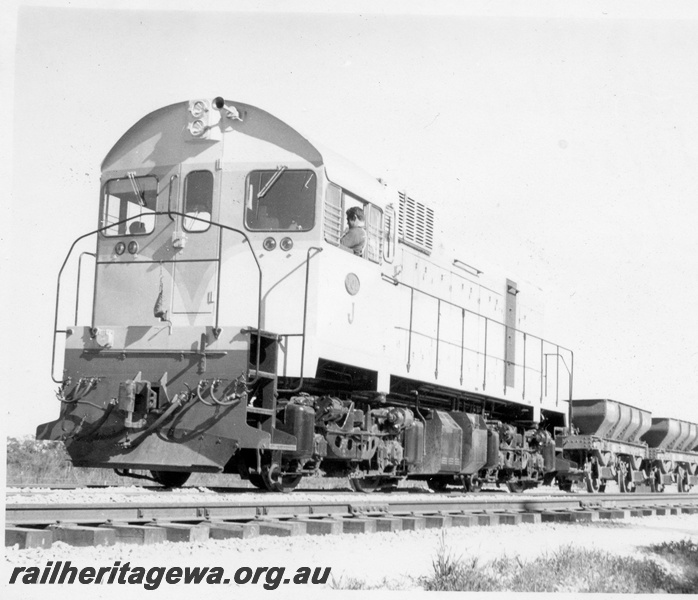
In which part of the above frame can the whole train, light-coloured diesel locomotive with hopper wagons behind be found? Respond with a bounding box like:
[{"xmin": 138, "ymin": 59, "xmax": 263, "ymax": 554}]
[{"xmin": 37, "ymin": 97, "xmax": 698, "ymax": 492}]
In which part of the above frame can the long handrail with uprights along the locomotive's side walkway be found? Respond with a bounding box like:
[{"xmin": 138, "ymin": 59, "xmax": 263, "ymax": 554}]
[{"xmin": 382, "ymin": 274, "xmax": 574, "ymax": 406}]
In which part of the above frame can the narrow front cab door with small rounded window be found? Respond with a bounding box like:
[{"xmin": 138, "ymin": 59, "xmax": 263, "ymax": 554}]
[{"xmin": 172, "ymin": 165, "xmax": 221, "ymax": 324}]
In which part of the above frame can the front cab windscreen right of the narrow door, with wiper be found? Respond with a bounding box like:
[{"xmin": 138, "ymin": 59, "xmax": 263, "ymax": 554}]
[{"xmin": 245, "ymin": 171, "xmax": 317, "ymax": 231}]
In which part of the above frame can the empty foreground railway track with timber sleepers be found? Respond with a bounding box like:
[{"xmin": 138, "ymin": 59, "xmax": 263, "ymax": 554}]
[{"xmin": 5, "ymin": 493, "xmax": 698, "ymax": 548}]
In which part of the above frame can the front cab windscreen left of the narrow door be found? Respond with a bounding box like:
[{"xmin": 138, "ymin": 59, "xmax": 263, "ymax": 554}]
[{"xmin": 102, "ymin": 176, "xmax": 158, "ymax": 236}]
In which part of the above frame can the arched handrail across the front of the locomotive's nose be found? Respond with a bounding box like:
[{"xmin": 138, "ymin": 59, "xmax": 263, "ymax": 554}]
[{"xmin": 51, "ymin": 207, "xmax": 262, "ymax": 384}]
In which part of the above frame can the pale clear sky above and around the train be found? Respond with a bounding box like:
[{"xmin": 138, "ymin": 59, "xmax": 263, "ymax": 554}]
[{"xmin": 0, "ymin": 0, "xmax": 698, "ymax": 435}]
